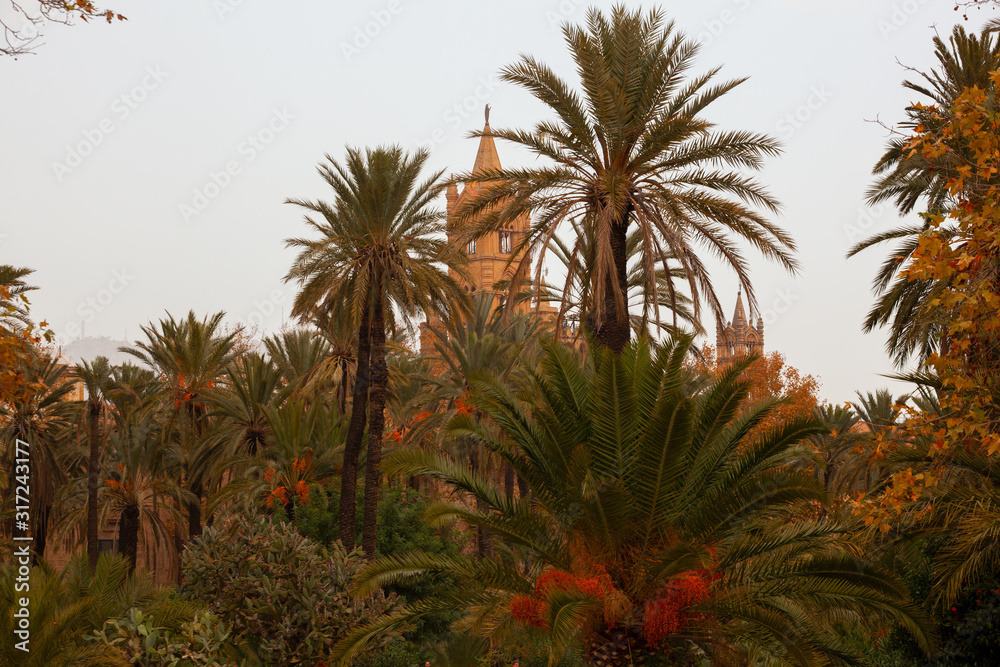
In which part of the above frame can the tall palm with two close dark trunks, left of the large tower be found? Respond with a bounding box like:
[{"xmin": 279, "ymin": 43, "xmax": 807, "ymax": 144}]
[{"xmin": 285, "ymin": 146, "xmax": 464, "ymax": 556}]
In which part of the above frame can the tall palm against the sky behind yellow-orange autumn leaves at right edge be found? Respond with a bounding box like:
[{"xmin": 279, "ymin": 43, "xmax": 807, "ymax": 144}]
[{"xmin": 847, "ymin": 25, "xmax": 1000, "ymax": 366}]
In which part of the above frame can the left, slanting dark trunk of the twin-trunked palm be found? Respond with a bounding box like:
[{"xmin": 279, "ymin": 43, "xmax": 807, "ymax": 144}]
[{"xmin": 338, "ymin": 312, "xmax": 371, "ymax": 551}]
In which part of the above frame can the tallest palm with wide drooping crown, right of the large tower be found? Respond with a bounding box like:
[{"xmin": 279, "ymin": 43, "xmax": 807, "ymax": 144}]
[{"xmin": 456, "ymin": 5, "xmax": 796, "ymax": 352}]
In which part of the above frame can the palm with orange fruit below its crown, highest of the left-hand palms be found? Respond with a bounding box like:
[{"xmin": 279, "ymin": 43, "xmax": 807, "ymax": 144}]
[{"xmin": 120, "ymin": 311, "xmax": 238, "ymax": 539}]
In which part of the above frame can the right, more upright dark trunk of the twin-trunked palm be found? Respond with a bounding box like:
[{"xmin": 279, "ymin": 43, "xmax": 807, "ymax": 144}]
[{"xmin": 361, "ymin": 295, "xmax": 389, "ymax": 559}]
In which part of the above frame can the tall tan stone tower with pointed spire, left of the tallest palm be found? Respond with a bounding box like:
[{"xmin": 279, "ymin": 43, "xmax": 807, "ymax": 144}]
[{"xmin": 420, "ymin": 106, "xmax": 548, "ymax": 353}]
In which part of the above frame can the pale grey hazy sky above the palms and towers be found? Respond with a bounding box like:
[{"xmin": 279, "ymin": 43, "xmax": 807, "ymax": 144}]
[{"xmin": 0, "ymin": 0, "xmax": 993, "ymax": 402}]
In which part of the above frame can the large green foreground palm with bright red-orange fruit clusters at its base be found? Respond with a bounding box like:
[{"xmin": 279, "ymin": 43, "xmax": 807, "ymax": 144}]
[{"xmin": 334, "ymin": 337, "xmax": 933, "ymax": 665}]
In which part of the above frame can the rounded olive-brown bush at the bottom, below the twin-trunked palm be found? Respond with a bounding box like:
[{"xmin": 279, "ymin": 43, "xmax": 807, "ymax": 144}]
[{"xmin": 182, "ymin": 515, "xmax": 400, "ymax": 665}]
